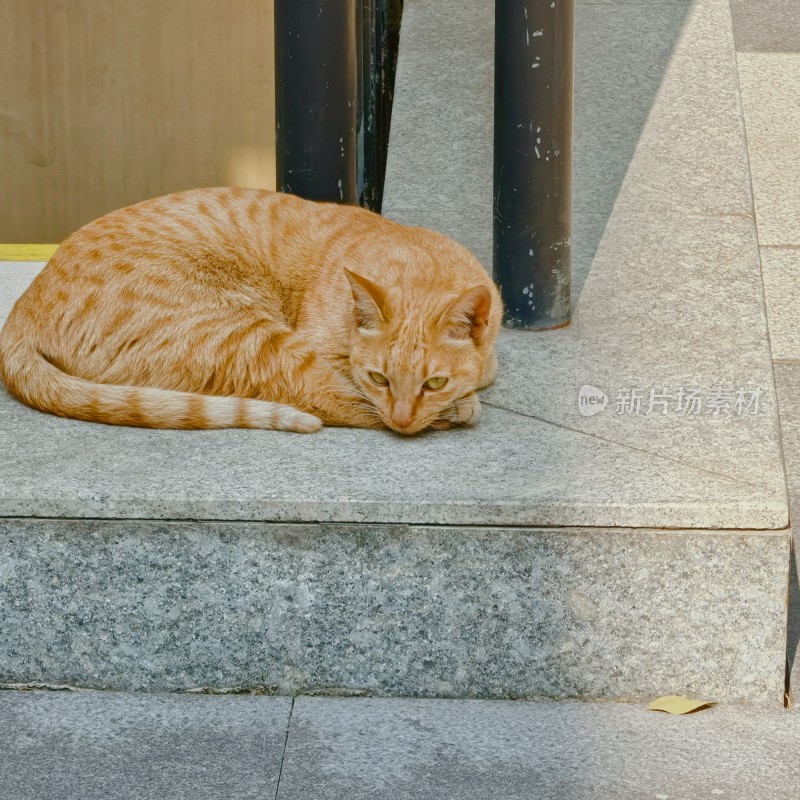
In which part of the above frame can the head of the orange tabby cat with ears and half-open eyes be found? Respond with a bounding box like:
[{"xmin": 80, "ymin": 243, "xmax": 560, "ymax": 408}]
[{"xmin": 345, "ymin": 270, "xmax": 492, "ymax": 434}]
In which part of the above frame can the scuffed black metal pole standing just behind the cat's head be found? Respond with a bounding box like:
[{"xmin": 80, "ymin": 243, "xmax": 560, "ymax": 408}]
[{"xmin": 494, "ymin": 0, "xmax": 575, "ymax": 330}]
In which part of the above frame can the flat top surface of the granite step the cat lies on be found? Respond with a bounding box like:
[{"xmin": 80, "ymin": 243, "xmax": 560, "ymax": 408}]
[{"xmin": 0, "ymin": 0, "xmax": 788, "ymax": 529}]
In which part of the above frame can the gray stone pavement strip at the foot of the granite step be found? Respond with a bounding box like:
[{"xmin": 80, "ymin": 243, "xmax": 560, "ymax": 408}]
[{"xmin": 0, "ymin": 692, "xmax": 800, "ymax": 800}]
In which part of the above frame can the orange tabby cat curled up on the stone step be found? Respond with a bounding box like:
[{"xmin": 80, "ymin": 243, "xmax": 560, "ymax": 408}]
[{"xmin": 0, "ymin": 189, "xmax": 501, "ymax": 434}]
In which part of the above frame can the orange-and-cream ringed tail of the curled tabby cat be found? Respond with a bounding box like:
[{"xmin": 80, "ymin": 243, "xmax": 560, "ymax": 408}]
[{"xmin": 0, "ymin": 330, "xmax": 322, "ymax": 433}]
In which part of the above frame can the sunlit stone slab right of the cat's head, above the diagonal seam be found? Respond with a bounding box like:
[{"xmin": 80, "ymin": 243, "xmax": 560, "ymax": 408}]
[{"xmin": 484, "ymin": 215, "xmax": 786, "ymax": 512}]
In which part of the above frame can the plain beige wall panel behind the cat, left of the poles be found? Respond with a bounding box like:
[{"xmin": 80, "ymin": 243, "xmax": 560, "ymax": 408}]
[{"xmin": 0, "ymin": 0, "xmax": 275, "ymax": 243}]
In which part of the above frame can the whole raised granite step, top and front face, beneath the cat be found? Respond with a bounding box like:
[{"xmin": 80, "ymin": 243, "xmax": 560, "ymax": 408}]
[{"xmin": 0, "ymin": 0, "xmax": 790, "ymax": 705}]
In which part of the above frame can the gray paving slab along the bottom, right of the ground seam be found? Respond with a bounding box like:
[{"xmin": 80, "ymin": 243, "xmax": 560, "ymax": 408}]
[{"xmin": 278, "ymin": 697, "xmax": 800, "ymax": 800}]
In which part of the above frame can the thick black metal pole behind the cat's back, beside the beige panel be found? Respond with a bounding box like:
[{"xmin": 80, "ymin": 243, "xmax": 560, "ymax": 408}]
[{"xmin": 275, "ymin": 0, "xmax": 360, "ymax": 203}]
